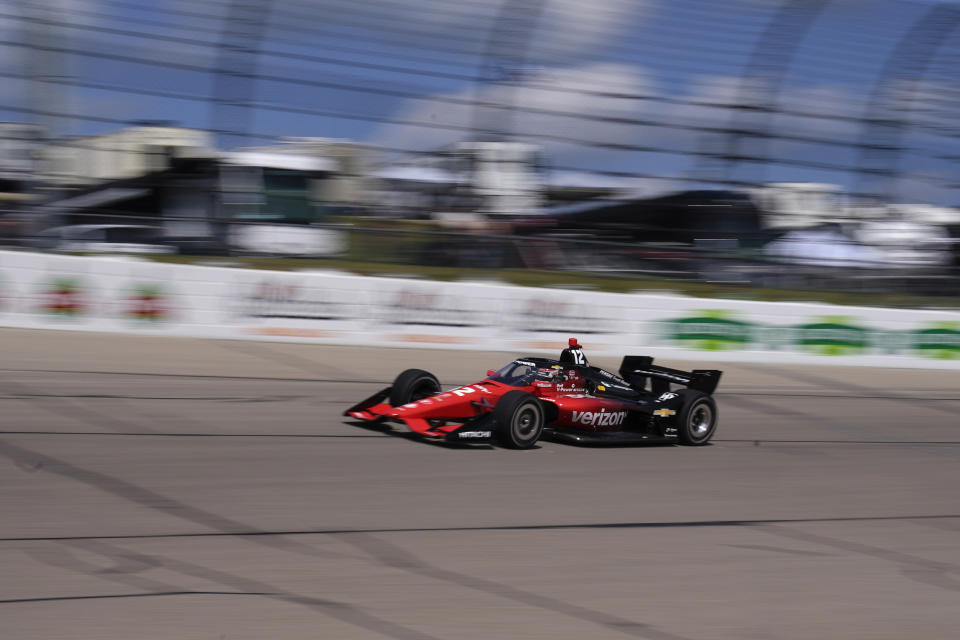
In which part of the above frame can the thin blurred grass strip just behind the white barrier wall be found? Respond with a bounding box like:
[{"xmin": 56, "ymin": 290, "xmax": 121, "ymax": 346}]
[{"xmin": 144, "ymin": 255, "xmax": 960, "ymax": 309}]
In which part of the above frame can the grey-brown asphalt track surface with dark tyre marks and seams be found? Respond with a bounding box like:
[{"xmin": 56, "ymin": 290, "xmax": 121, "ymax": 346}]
[{"xmin": 0, "ymin": 329, "xmax": 960, "ymax": 640}]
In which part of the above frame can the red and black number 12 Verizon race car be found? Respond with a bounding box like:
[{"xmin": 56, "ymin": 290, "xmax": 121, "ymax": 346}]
[{"xmin": 343, "ymin": 338, "xmax": 722, "ymax": 449}]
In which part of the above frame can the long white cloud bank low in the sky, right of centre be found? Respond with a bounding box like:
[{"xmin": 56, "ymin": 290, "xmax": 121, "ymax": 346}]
[{"xmin": 372, "ymin": 64, "xmax": 863, "ymax": 166}]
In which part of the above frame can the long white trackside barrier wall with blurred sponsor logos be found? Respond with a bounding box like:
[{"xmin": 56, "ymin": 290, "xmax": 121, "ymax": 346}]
[{"xmin": 0, "ymin": 251, "xmax": 960, "ymax": 368}]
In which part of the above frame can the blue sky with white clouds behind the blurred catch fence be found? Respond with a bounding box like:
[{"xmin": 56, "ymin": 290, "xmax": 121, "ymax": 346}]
[{"xmin": 0, "ymin": 0, "xmax": 960, "ymax": 203}]
